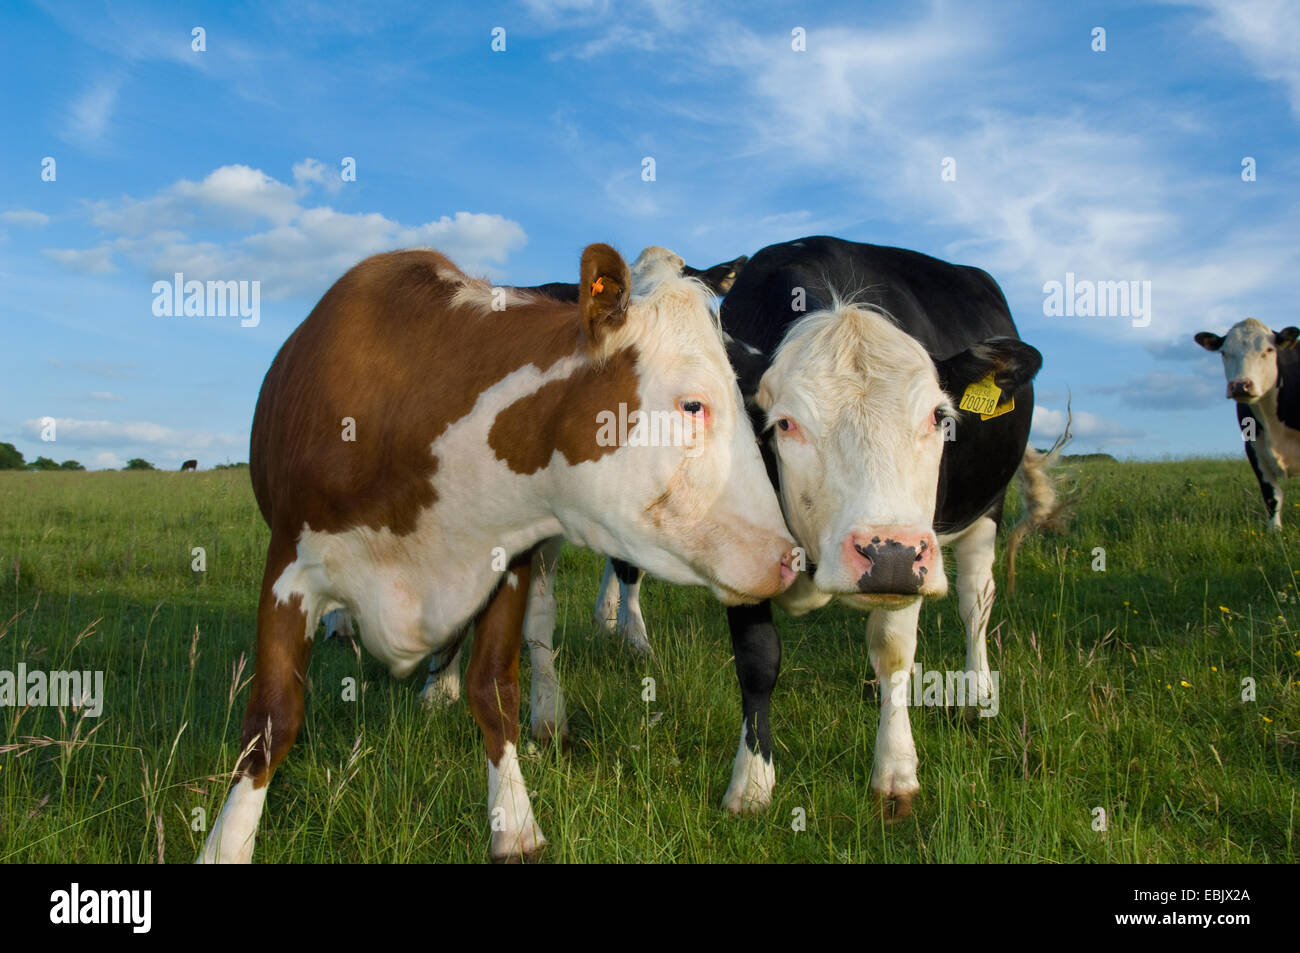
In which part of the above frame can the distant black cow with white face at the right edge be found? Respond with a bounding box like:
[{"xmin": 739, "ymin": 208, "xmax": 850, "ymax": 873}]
[{"xmin": 1196, "ymin": 317, "xmax": 1300, "ymax": 529}]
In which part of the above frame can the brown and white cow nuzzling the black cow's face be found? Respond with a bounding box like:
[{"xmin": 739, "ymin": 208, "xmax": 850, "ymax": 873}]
[{"xmin": 200, "ymin": 244, "xmax": 794, "ymax": 862}]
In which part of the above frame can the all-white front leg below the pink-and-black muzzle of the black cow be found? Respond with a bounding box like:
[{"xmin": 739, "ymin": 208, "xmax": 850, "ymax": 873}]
[{"xmin": 867, "ymin": 599, "xmax": 920, "ymax": 820}]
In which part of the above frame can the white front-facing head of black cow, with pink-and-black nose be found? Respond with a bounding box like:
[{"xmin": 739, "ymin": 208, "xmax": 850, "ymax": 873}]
[{"xmin": 757, "ymin": 304, "xmax": 1043, "ymax": 611}]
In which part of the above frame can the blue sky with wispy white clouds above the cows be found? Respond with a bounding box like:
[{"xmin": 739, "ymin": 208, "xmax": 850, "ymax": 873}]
[{"xmin": 0, "ymin": 0, "xmax": 1300, "ymax": 468}]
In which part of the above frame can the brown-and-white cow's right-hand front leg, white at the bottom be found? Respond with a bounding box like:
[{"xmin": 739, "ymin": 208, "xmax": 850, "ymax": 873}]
[{"xmin": 465, "ymin": 551, "xmax": 546, "ymax": 862}]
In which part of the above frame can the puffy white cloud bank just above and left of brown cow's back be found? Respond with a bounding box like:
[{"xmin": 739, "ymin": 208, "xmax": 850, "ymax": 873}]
[{"xmin": 46, "ymin": 159, "xmax": 528, "ymax": 300}]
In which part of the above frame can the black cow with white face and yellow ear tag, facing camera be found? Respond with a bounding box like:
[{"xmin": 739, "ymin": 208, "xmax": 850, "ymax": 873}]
[{"xmin": 525, "ymin": 237, "xmax": 1056, "ymax": 818}]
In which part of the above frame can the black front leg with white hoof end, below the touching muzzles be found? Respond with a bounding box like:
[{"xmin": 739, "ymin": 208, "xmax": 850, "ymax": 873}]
[{"xmin": 723, "ymin": 602, "xmax": 781, "ymax": 814}]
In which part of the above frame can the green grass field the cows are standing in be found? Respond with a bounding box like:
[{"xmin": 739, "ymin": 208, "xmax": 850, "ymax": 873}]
[{"xmin": 0, "ymin": 459, "xmax": 1300, "ymax": 863}]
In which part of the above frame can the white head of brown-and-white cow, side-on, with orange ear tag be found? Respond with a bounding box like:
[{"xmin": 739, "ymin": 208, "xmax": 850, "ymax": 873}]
[{"xmin": 560, "ymin": 244, "xmax": 794, "ymax": 605}]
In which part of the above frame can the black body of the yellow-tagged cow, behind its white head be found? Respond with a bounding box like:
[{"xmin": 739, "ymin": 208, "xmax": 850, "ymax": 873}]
[{"xmin": 722, "ymin": 235, "xmax": 1034, "ymax": 533}]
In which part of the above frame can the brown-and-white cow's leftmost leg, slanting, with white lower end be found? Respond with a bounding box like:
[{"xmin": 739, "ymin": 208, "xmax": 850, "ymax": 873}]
[{"xmin": 199, "ymin": 538, "xmax": 316, "ymax": 863}]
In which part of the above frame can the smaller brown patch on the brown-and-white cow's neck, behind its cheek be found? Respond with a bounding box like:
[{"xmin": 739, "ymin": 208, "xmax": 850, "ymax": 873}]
[{"xmin": 488, "ymin": 347, "xmax": 641, "ymax": 475}]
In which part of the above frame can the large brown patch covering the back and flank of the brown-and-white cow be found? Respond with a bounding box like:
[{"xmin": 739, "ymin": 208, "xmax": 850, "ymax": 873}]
[{"xmin": 250, "ymin": 246, "xmax": 627, "ymax": 540}]
